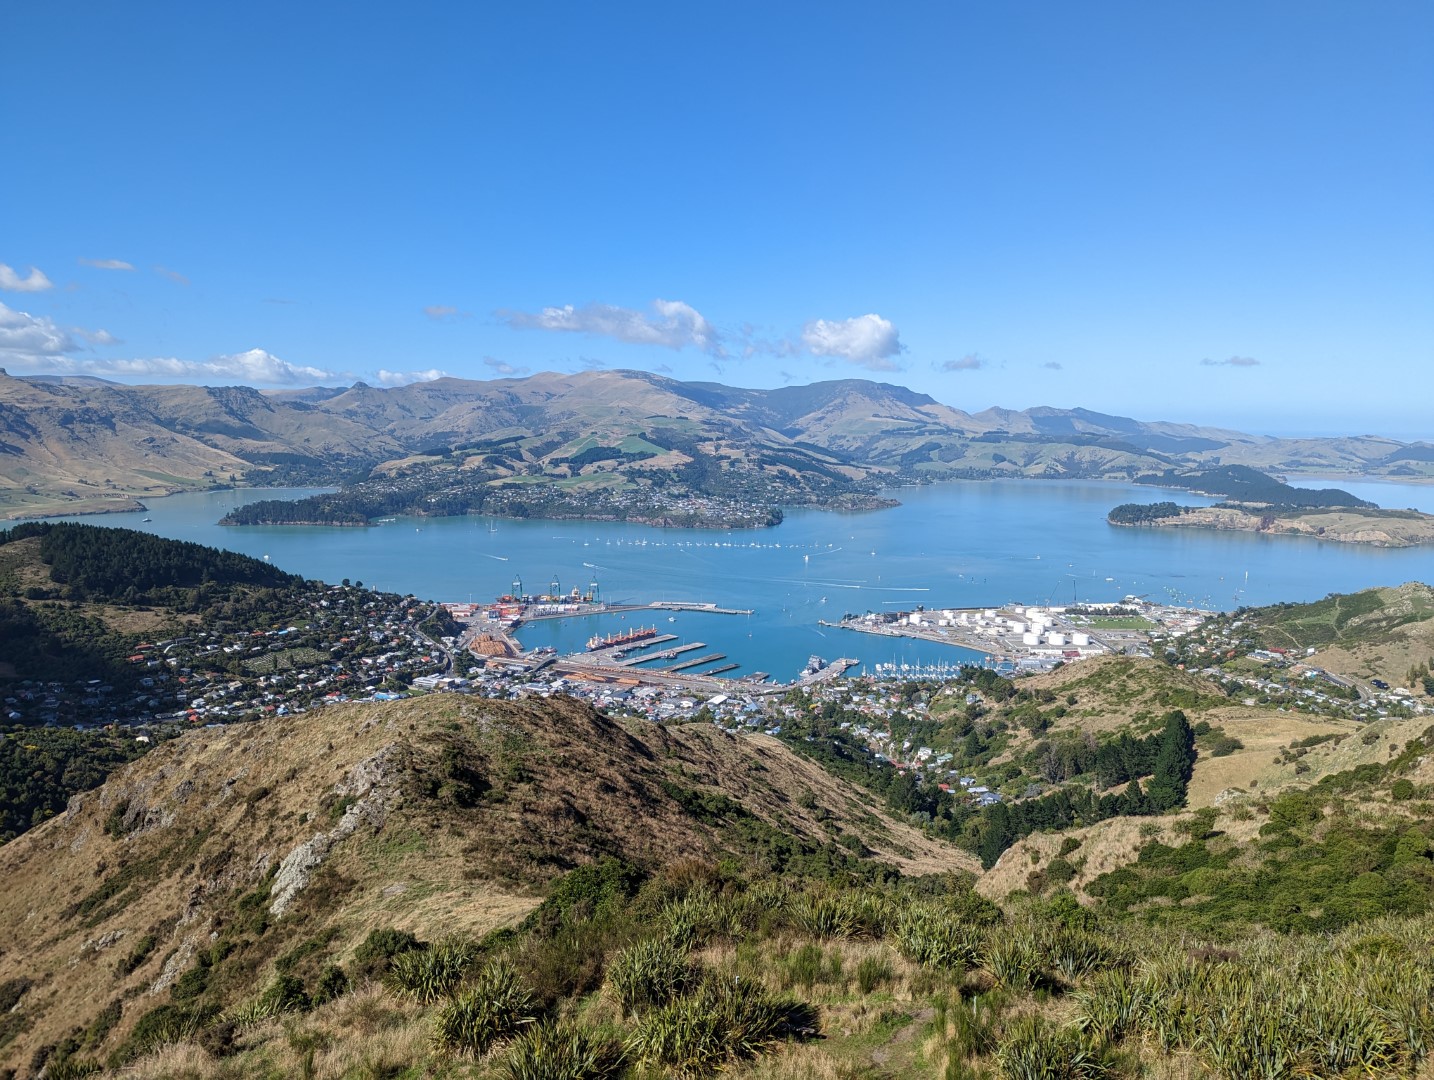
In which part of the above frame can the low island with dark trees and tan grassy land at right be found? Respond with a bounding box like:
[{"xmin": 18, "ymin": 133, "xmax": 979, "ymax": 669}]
[{"xmin": 1106, "ymin": 466, "xmax": 1434, "ymax": 548}]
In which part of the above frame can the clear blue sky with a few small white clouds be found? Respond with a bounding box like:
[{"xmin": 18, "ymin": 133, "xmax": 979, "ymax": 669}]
[{"xmin": 0, "ymin": 0, "xmax": 1434, "ymax": 437}]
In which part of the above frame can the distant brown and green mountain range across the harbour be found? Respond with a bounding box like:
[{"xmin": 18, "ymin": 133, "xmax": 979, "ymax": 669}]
[{"xmin": 0, "ymin": 371, "xmax": 1434, "ymax": 516}]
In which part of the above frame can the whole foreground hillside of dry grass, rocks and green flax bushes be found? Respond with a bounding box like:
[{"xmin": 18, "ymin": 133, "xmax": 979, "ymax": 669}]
[{"xmin": 8, "ymin": 697, "xmax": 1434, "ymax": 1080}]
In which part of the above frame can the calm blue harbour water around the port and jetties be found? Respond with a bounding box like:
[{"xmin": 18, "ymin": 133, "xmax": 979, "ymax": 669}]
[{"xmin": 13, "ymin": 480, "xmax": 1434, "ymax": 680}]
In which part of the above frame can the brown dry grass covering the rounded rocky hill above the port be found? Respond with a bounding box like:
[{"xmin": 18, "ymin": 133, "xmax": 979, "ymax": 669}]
[{"xmin": 0, "ymin": 696, "xmax": 971, "ymax": 1066}]
